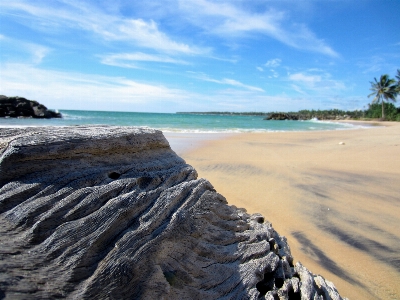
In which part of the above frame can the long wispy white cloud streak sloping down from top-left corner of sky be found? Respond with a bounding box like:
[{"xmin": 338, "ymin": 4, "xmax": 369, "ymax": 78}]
[{"xmin": 0, "ymin": 0, "xmax": 211, "ymax": 55}]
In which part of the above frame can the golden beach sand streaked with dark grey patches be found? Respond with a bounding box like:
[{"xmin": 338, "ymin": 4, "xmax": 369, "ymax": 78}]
[{"xmin": 180, "ymin": 122, "xmax": 400, "ymax": 299}]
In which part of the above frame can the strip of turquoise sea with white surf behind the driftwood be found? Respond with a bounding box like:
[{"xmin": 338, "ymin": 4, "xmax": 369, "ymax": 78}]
[{"xmin": 0, "ymin": 110, "xmax": 368, "ymax": 133}]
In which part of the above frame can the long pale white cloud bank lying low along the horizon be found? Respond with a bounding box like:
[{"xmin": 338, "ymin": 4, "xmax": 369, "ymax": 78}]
[{"xmin": 0, "ymin": 64, "xmax": 362, "ymax": 112}]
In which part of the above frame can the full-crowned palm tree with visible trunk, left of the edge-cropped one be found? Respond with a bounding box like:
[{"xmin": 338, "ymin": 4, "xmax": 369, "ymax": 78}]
[{"xmin": 368, "ymin": 74, "xmax": 398, "ymax": 120}]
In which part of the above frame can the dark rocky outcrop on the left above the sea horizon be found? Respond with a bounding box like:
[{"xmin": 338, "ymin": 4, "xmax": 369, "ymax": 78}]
[{"xmin": 0, "ymin": 95, "xmax": 62, "ymax": 119}]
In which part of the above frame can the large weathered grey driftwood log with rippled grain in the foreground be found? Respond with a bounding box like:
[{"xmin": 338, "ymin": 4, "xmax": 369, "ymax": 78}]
[{"xmin": 0, "ymin": 126, "xmax": 342, "ymax": 299}]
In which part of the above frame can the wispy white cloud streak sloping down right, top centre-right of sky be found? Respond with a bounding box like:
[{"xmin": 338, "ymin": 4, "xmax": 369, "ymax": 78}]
[{"xmin": 179, "ymin": 0, "xmax": 339, "ymax": 57}]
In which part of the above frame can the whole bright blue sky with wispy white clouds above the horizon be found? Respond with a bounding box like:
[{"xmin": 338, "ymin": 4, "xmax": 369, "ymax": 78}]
[{"xmin": 0, "ymin": 0, "xmax": 400, "ymax": 113}]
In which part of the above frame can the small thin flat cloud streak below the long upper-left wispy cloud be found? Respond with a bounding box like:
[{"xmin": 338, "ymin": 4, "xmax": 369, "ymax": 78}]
[{"xmin": 101, "ymin": 52, "xmax": 188, "ymax": 68}]
